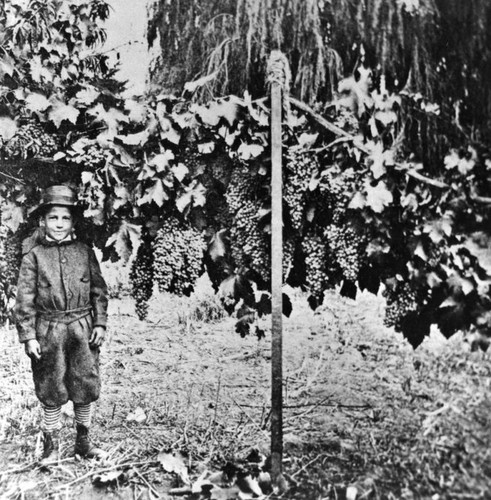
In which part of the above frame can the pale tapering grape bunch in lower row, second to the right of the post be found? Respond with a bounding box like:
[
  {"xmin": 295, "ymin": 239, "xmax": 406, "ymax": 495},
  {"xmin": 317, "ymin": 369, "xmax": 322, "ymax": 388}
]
[{"xmin": 324, "ymin": 224, "xmax": 366, "ymax": 281}]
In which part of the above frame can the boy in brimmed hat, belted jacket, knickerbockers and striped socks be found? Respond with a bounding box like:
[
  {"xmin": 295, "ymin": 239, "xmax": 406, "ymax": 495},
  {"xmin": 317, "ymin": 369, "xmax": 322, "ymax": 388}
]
[{"xmin": 15, "ymin": 186, "xmax": 107, "ymax": 465}]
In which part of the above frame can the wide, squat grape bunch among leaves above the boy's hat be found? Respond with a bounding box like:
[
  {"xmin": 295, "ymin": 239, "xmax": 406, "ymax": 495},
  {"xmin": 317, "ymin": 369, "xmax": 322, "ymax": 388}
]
[{"xmin": 5, "ymin": 122, "xmax": 59, "ymax": 159}]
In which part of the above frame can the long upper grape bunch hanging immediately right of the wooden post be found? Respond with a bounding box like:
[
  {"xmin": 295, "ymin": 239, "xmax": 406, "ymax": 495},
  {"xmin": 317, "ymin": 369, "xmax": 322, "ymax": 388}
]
[{"xmin": 283, "ymin": 150, "xmax": 318, "ymax": 229}]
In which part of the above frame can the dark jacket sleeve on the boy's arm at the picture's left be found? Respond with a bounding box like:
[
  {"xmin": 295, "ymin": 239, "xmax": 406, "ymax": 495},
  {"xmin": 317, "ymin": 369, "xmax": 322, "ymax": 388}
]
[{"xmin": 14, "ymin": 252, "xmax": 37, "ymax": 343}]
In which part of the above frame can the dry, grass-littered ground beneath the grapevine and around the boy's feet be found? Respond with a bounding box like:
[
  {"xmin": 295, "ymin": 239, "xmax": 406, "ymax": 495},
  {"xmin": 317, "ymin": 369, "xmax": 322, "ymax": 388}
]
[{"xmin": 0, "ymin": 276, "xmax": 491, "ymax": 500}]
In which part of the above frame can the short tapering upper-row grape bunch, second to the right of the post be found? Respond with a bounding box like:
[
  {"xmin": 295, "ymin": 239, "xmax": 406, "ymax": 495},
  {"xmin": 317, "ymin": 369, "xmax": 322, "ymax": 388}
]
[{"xmin": 319, "ymin": 169, "xmax": 358, "ymax": 225}]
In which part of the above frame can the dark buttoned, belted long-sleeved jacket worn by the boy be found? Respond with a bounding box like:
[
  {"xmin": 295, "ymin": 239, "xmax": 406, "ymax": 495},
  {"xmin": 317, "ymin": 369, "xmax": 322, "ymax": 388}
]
[{"xmin": 14, "ymin": 239, "xmax": 108, "ymax": 342}]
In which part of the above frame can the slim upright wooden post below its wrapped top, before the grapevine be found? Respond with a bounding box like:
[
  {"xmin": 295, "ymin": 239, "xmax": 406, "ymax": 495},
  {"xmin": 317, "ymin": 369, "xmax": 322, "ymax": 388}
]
[{"xmin": 271, "ymin": 68, "xmax": 283, "ymax": 486}]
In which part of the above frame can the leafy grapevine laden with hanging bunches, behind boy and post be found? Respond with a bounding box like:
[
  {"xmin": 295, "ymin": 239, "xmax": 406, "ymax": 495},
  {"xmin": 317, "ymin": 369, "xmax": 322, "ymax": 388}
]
[{"xmin": 0, "ymin": 0, "xmax": 491, "ymax": 346}]
